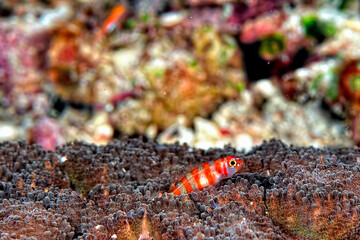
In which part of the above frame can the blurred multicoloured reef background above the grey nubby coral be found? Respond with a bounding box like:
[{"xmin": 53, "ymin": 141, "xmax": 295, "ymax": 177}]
[{"xmin": 0, "ymin": 0, "xmax": 360, "ymax": 150}]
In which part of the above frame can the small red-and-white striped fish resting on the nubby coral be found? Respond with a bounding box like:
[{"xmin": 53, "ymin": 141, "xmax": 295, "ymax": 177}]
[{"xmin": 170, "ymin": 156, "xmax": 244, "ymax": 196}]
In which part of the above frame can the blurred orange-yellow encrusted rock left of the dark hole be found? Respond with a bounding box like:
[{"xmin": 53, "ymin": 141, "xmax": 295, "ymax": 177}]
[{"xmin": 110, "ymin": 26, "xmax": 246, "ymax": 135}]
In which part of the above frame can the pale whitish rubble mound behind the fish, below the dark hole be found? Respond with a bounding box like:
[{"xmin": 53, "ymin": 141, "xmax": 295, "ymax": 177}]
[{"xmin": 157, "ymin": 79, "xmax": 352, "ymax": 151}]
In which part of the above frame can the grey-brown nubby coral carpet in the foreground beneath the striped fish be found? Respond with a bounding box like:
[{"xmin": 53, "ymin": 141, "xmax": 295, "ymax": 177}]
[{"xmin": 0, "ymin": 138, "xmax": 360, "ymax": 240}]
